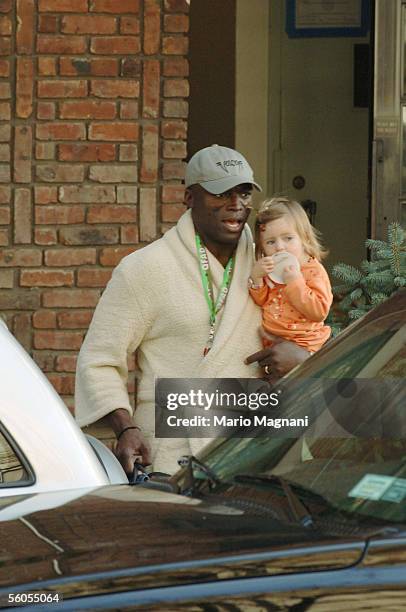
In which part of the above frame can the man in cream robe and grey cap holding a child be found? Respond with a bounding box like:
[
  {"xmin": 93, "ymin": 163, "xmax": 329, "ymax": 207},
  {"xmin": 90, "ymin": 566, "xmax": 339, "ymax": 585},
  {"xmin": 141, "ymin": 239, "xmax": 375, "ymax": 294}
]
[{"xmin": 76, "ymin": 145, "xmax": 310, "ymax": 474}]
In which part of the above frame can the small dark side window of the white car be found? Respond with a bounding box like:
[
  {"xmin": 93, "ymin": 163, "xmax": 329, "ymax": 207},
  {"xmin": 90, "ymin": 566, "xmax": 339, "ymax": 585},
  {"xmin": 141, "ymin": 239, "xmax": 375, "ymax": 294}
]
[{"xmin": 0, "ymin": 427, "xmax": 34, "ymax": 488}]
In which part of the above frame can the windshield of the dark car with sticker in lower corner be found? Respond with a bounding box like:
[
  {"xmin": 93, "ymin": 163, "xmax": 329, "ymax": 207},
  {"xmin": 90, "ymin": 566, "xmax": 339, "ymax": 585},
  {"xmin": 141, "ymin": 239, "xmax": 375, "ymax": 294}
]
[{"xmin": 195, "ymin": 309, "xmax": 406, "ymax": 522}]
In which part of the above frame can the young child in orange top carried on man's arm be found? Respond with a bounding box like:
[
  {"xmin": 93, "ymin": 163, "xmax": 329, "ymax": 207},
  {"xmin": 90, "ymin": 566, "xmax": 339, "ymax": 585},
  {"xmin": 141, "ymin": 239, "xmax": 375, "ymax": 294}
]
[{"xmin": 249, "ymin": 197, "xmax": 333, "ymax": 354}]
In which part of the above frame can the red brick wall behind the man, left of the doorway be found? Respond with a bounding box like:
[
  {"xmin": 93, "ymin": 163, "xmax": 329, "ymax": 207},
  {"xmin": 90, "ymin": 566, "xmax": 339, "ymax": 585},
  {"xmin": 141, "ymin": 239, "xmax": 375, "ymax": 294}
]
[{"xmin": 0, "ymin": 0, "xmax": 189, "ymax": 406}]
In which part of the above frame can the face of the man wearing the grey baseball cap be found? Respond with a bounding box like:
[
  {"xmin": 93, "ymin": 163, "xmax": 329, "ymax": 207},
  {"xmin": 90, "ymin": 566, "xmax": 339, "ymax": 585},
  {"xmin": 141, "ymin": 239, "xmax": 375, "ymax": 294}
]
[{"xmin": 185, "ymin": 183, "xmax": 252, "ymax": 249}]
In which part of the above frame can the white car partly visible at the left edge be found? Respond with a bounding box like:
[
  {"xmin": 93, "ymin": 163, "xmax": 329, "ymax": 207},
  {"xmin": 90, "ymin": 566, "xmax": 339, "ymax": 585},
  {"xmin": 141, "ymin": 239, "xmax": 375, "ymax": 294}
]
[{"xmin": 0, "ymin": 319, "xmax": 128, "ymax": 498}]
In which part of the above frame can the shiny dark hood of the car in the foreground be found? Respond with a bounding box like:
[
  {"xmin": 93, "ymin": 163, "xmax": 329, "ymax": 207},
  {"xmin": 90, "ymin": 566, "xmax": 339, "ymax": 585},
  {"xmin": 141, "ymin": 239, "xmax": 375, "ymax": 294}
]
[{"xmin": 0, "ymin": 485, "xmax": 365, "ymax": 597}]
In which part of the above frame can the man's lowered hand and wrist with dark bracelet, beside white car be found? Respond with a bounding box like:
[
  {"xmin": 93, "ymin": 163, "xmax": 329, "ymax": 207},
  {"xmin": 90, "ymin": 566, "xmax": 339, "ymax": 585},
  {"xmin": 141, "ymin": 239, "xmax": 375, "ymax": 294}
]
[{"xmin": 107, "ymin": 408, "xmax": 151, "ymax": 476}]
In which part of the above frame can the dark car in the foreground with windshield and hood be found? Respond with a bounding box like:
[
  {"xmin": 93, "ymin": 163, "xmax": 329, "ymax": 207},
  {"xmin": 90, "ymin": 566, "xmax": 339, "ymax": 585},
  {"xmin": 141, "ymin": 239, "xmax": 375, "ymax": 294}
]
[{"xmin": 0, "ymin": 291, "xmax": 406, "ymax": 612}]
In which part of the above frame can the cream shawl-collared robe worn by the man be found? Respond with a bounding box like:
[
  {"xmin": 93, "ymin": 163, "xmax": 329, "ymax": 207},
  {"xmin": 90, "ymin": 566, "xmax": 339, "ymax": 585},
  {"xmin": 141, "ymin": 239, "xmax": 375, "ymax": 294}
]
[{"xmin": 76, "ymin": 211, "xmax": 261, "ymax": 473}]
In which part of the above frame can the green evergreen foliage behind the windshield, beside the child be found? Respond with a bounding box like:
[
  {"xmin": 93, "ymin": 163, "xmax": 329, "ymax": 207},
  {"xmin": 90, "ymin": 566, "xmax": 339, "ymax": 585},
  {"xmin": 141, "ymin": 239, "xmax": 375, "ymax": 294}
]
[{"xmin": 327, "ymin": 222, "xmax": 406, "ymax": 336}]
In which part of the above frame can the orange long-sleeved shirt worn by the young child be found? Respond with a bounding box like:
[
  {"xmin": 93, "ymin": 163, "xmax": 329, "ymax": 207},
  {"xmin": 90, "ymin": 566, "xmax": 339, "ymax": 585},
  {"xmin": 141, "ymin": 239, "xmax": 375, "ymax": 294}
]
[{"xmin": 249, "ymin": 258, "xmax": 333, "ymax": 352}]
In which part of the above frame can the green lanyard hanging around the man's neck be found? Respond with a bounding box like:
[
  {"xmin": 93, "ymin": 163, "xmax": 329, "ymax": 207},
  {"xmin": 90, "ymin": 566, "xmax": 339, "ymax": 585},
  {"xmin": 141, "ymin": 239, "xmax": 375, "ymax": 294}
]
[{"xmin": 196, "ymin": 234, "xmax": 234, "ymax": 357}]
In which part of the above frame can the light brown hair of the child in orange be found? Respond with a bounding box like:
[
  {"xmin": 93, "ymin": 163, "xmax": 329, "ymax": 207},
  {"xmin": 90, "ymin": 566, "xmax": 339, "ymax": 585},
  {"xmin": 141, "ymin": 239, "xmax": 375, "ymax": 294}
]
[{"xmin": 255, "ymin": 197, "xmax": 328, "ymax": 261}]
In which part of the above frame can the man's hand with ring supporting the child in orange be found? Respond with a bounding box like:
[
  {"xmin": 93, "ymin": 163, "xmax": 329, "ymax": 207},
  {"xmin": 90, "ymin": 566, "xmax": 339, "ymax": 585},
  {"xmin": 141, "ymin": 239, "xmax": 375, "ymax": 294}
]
[{"xmin": 245, "ymin": 327, "xmax": 309, "ymax": 382}]
